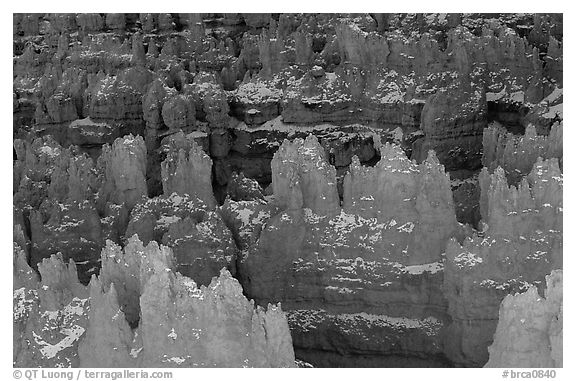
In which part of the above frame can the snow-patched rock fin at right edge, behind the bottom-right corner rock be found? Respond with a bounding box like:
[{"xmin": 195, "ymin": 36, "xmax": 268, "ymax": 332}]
[{"xmin": 444, "ymin": 159, "xmax": 563, "ymax": 366}]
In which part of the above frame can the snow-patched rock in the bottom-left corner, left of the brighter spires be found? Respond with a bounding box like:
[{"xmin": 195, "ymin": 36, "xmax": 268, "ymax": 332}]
[{"xmin": 13, "ymin": 252, "xmax": 90, "ymax": 368}]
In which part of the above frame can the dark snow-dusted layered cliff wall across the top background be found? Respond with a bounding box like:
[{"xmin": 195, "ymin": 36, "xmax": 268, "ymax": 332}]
[{"xmin": 14, "ymin": 14, "xmax": 562, "ymax": 163}]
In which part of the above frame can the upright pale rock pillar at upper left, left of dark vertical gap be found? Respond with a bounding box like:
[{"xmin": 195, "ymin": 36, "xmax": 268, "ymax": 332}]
[{"xmin": 98, "ymin": 135, "xmax": 148, "ymax": 210}]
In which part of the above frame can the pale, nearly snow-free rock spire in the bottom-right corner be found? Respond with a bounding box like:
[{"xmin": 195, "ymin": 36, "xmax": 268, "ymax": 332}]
[{"xmin": 485, "ymin": 270, "xmax": 563, "ymax": 368}]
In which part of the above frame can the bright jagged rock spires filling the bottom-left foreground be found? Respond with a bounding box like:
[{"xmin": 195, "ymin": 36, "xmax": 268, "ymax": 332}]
[{"xmin": 14, "ymin": 237, "xmax": 295, "ymax": 367}]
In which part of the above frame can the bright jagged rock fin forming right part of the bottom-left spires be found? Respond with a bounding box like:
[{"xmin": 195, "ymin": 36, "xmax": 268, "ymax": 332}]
[{"xmin": 140, "ymin": 262, "xmax": 294, "ymax": 367}]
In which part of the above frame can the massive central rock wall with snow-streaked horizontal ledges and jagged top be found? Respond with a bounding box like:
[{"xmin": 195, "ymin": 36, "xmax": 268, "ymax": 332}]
[{"xmin": 238, "ymin": 141, "xmax": 460, "ymax": 366}]
